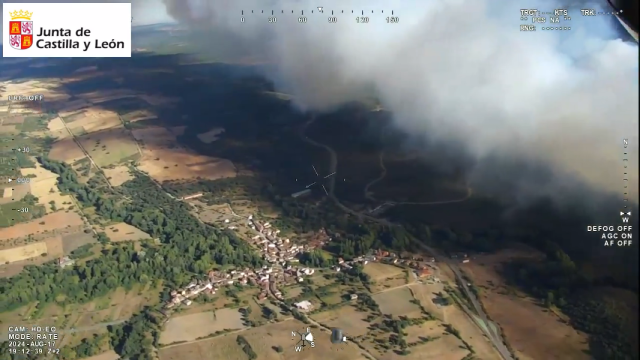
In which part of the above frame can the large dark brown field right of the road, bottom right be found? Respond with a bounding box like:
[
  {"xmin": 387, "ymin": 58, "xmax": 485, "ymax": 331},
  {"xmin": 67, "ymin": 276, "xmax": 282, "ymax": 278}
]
[{"xmin": 462, "ymin": 250, "xmax": 589, "ymax": 360}]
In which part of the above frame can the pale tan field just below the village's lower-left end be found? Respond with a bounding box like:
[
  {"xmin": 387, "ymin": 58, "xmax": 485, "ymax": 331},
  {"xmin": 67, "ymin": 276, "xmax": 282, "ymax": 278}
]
[{"xmin": 160, "ymin": 308, "xmax": 245, "ymax": 345}]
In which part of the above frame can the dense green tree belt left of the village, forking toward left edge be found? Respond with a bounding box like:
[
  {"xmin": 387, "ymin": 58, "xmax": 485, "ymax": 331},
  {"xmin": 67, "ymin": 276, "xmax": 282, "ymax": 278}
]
[{"xmin": 0, "ymin": 158, "xmax": 263, "ymax": 311}]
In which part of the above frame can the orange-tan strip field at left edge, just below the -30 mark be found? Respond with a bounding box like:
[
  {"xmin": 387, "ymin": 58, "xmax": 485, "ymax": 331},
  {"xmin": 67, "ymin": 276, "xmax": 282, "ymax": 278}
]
[{"xmin": 0, "ymin": 211, "xmax": 84, "ymax": 242}]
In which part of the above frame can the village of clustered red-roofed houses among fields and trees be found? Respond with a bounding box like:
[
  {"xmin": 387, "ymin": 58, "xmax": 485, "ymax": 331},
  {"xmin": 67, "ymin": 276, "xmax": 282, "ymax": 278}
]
[{"xmin": 165, "ymin": 215, "xmax": 448, "ymax": 311}]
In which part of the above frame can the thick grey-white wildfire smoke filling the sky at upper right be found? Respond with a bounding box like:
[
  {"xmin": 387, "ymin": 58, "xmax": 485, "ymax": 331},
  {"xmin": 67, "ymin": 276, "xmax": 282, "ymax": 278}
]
[{"xmin": 2, "ymin": 0, "xmax": 639, "ymax": 211}]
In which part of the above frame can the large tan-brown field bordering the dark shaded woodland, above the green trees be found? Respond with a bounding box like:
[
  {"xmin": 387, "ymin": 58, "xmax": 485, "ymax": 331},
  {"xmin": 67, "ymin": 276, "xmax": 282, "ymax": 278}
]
[{"xmin": 132, "ymin": 127, "xmax": 236, "ymax": 183}]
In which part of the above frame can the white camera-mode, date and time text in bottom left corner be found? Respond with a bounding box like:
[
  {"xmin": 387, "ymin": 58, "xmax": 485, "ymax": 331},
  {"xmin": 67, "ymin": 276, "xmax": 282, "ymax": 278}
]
[{"xmin": 4, "ymin": 324, "xmax": 61, "ymax": 356}]
